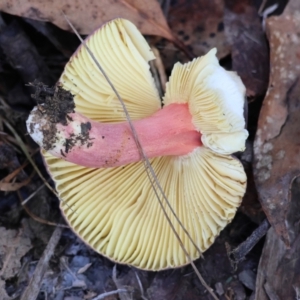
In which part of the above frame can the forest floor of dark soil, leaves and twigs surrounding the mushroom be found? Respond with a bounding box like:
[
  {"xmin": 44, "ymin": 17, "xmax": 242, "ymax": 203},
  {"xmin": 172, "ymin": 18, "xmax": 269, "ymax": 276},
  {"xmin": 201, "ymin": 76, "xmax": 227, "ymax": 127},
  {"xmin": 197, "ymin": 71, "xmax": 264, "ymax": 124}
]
[{"xmin": 0, "ymin": 0, "xmax": 300, "ymax": 300}]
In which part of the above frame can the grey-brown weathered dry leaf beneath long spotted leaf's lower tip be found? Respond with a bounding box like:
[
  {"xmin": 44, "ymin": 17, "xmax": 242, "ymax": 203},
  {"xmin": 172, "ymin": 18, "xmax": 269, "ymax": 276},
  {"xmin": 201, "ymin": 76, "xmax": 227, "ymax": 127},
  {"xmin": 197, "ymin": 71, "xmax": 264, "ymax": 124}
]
[{"xmin": 255, "ymin": 178, "xmax": 300, "ymax": 300}]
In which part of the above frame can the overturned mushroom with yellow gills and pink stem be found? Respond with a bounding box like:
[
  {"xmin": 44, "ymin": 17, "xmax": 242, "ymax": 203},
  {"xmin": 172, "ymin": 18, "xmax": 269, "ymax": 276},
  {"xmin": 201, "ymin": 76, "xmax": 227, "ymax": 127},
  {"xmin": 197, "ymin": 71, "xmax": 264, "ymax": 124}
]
[{"xmin": 27, "ymin": 19, "xmax": 248, "ymax": 270}]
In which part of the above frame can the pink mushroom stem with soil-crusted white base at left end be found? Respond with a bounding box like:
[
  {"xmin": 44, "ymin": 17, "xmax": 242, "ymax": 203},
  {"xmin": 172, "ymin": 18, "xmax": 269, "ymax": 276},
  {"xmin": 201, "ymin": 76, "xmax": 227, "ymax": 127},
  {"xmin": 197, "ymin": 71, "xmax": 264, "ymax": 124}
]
[{"xmin": 27, "ymin": 104, "xmax": 202, "ymax": 168}]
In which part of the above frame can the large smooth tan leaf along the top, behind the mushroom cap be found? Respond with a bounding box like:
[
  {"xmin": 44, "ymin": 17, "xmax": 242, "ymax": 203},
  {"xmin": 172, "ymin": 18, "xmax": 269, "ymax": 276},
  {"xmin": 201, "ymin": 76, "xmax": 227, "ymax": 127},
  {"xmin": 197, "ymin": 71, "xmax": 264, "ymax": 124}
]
[{"xmin": 0, "ymin": 0, "xmax": 173, "ymax": 40}]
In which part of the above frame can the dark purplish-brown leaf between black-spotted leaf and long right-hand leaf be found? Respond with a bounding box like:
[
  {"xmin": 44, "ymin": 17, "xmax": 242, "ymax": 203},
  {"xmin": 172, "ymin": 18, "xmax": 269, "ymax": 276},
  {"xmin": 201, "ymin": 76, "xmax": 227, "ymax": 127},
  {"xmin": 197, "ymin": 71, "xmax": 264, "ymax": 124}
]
[{"xmin": 224, "ymin": 0, "xmax": 269, "ymax": 97}]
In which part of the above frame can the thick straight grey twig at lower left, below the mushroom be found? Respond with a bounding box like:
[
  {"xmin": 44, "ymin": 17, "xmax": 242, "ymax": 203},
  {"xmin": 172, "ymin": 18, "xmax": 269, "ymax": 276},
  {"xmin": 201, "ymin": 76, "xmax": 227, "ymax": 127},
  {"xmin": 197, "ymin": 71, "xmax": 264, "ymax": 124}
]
[{"xmin": 20, "ymin": 227, "xmax": 62, "ymax": 300}]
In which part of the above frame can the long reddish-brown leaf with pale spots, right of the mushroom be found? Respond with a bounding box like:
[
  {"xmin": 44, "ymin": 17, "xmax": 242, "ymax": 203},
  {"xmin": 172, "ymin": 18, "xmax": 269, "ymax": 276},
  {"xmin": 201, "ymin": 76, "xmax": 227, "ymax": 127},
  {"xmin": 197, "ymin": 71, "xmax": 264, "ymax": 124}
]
[{"xmin": 254, "ymin": 0, "xmax": 300, "ymax": 245}]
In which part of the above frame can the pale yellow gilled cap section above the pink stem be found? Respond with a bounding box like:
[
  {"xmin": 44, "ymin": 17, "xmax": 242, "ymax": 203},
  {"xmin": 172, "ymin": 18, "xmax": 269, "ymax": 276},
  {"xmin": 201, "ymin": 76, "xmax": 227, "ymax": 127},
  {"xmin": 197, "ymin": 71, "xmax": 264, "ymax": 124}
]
[{"xmin": 59, "ymin": 19, "xmax": 161, "ymax": 123}]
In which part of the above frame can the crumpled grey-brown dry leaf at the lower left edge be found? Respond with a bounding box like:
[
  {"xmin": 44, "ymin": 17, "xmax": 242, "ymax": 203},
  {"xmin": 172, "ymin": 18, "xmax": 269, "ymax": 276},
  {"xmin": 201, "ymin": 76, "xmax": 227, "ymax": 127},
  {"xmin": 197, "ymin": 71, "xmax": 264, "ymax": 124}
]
[{"xmin": 0, "ymin": 227, "xmax": 32, "ymax": 279}]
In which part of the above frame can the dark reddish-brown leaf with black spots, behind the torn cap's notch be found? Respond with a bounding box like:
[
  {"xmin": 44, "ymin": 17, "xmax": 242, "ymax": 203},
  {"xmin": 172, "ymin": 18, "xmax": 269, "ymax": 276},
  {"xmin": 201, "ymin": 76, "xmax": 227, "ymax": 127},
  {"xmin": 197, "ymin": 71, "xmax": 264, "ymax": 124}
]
[{"xmin": 149, "ymin": 0, "xmax": 230, "ymax": 70}]
